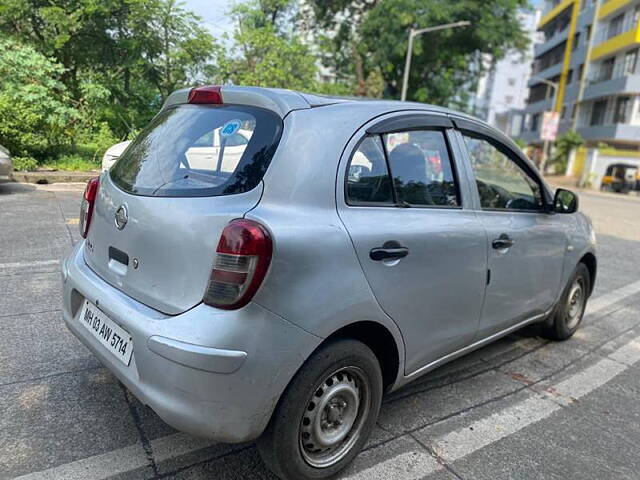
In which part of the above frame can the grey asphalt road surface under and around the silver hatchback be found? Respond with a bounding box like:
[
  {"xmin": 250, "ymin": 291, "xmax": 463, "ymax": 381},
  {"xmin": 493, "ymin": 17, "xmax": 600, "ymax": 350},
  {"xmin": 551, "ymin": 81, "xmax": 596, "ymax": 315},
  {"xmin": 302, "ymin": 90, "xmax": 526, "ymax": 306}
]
[{"xmin": 0, "ymin": 184, "xmax": 640, "ymax": 480}]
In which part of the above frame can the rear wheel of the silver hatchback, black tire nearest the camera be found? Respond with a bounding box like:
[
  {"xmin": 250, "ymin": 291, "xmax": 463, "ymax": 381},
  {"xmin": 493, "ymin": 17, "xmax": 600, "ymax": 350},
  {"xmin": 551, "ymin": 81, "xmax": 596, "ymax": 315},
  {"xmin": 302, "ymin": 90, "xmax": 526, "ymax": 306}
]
[{"xmin": 257, "ymin": 339, "xmax": 383, "ymax": 480}]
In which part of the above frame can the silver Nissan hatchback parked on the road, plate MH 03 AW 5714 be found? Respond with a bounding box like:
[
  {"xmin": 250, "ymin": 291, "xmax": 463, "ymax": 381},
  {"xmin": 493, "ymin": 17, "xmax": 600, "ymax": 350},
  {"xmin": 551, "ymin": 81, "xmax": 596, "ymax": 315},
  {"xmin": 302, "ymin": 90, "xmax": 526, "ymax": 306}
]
[{"xmin": 63, "ymin": 86, "xmax": 596, "ymax": 480}]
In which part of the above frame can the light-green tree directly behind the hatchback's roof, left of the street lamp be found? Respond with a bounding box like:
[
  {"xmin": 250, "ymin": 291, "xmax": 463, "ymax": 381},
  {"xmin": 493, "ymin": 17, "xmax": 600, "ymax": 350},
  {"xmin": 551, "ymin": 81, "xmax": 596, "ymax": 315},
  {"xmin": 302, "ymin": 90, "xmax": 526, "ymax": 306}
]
[{"xmin": 210, "ymin": 0, "xmax": 317, "ymax": 90}]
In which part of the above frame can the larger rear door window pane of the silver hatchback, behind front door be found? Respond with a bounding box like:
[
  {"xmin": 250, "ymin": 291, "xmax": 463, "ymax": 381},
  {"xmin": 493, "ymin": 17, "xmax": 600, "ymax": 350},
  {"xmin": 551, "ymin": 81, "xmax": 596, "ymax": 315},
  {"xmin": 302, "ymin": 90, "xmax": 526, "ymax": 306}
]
[{"xmin": 383, "ymin": 130, "xmax": 460, "ymax": 207}]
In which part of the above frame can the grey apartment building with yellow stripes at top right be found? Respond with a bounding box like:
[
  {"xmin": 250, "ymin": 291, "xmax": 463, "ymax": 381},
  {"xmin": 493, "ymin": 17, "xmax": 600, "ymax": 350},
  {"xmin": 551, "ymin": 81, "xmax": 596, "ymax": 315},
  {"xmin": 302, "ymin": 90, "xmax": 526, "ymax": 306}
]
[{"xmin": 521, "ymin": 0, "xmax": 640, "ymax": 150}]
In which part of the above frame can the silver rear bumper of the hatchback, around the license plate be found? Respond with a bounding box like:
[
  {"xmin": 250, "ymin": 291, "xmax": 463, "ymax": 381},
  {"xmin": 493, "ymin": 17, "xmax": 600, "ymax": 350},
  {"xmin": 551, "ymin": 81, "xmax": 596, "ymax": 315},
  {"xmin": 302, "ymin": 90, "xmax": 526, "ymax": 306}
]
[{"xmin": 62, "ymin": 242, "xmax": 321, "ymax": 442}]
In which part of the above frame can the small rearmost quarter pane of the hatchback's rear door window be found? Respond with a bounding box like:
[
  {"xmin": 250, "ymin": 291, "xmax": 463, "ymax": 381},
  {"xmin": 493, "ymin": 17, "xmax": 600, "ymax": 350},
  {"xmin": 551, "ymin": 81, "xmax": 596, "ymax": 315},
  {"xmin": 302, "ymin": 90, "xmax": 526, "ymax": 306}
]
[{"xmin": 347, "ymin": 135, "xmax": 393, "ymax": 205}]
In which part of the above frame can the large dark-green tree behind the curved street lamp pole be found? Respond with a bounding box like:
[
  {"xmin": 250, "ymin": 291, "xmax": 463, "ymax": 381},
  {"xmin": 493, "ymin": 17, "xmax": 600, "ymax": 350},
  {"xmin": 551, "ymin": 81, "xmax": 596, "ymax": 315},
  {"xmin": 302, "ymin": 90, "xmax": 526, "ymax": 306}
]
[{"xmin": 309, "ymin": 0, "xmax": 528, "ymax": 104}]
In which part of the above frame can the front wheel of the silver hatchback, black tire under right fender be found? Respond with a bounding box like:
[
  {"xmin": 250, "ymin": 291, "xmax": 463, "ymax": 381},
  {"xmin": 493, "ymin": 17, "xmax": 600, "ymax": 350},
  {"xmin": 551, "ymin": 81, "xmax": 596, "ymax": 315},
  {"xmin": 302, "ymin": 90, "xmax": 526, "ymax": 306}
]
[{"xmin": 542, "ymin": 263, "xmax": 591, "ymax": 341}]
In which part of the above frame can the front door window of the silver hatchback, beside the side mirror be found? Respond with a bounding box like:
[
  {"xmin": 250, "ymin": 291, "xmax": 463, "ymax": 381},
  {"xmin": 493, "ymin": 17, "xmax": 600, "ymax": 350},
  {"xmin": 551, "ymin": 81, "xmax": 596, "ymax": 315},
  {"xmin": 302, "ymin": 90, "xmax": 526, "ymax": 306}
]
[{"xmin": 462, "ymin": 133, "xmax": 544, "ymax": 211}]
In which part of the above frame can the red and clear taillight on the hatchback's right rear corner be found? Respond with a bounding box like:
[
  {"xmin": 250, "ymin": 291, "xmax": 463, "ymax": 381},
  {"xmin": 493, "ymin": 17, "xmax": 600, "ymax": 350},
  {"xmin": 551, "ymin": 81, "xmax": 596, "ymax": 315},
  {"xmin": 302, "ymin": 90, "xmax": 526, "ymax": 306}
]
[{"xmin": 204, "ymin": 218, "xmax": 273, "ymax": 310}]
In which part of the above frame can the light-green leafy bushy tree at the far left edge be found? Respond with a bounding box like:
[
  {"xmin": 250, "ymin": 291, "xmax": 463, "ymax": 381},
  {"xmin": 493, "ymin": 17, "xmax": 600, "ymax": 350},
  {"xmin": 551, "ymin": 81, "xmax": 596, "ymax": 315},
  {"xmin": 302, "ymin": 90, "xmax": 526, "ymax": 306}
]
[{"xmin": 0, "ymin": 39, "xmax": 82, "ymax": 160}]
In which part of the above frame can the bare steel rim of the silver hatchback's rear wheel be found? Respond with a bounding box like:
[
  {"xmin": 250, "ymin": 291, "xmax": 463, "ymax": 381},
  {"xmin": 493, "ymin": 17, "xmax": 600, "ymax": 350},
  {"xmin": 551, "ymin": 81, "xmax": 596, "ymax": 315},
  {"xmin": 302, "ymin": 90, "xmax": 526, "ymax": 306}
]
[{"xmin": 298, "ymin": 366, "xmax": 371, "ymax": 468}]
